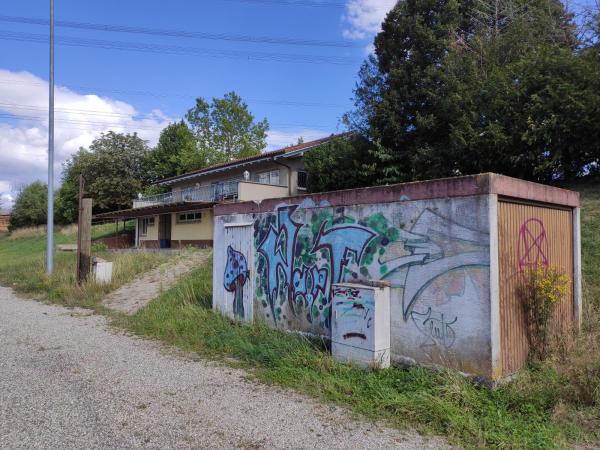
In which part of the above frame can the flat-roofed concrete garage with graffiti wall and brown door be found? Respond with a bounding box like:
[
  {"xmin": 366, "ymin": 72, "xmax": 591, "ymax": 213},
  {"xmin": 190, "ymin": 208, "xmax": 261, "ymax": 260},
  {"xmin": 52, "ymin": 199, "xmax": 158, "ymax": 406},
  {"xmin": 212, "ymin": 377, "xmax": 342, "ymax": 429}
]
[{"xmin": 213, "ymin": 174, "xmax": 582, "ymax": 382}]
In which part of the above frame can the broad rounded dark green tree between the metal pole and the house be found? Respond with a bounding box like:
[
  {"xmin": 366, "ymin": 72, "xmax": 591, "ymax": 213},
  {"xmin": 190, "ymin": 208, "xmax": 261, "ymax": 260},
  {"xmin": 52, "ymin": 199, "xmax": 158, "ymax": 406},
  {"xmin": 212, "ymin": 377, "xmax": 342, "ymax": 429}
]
[{"xmin": 56, "ymin": 131, "xmax": 152, "ymax": 223}]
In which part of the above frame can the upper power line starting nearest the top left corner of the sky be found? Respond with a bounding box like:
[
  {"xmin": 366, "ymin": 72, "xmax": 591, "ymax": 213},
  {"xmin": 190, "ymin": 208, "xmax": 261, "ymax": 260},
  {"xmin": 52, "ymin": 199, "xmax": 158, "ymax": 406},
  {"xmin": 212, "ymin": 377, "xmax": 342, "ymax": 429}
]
[{"xmin": 0, "ymin": 15, "xmax": 362, "ymax": 48}]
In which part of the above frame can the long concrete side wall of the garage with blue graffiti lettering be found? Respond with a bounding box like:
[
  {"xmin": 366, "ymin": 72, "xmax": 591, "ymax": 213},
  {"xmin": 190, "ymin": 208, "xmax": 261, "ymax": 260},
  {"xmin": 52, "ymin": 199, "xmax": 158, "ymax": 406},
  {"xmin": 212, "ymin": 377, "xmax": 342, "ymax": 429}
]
[{"xmin": 213, "ymin": 195, "xmax": 492, "ymax": 376}]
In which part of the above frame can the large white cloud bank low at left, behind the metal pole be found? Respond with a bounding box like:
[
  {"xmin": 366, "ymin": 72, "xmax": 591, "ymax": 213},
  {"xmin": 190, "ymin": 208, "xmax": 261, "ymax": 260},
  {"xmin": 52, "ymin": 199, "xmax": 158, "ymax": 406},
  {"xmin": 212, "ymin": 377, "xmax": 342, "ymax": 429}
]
[{"xmin": 0, "ymin": 70, "xmax": 172, "ymax": 207}]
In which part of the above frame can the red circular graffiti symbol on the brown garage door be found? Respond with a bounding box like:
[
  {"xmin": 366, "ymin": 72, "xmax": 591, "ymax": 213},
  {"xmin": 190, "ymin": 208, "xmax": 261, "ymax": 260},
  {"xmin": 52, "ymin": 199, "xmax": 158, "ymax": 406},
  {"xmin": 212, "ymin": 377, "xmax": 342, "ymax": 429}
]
[{"xmin": 517, "ymin": 219, "xmax": 548, "ymax": 272}]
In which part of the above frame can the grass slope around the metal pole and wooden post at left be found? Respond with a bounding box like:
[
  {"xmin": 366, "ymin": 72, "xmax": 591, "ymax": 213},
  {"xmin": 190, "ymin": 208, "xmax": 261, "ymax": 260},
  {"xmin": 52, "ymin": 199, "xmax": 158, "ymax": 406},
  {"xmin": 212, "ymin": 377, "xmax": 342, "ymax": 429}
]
[{"xmin": 0, "ymin": 225, "xmax": 168, "ymax": 308}]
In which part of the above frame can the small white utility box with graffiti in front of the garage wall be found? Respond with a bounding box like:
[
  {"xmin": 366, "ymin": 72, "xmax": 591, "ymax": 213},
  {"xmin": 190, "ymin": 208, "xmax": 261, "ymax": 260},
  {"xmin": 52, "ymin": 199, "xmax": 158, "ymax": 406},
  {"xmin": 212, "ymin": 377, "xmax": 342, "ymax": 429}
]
[{"xmin": 331, "ymin": 282, "xmax": 391, "ymax": 368}]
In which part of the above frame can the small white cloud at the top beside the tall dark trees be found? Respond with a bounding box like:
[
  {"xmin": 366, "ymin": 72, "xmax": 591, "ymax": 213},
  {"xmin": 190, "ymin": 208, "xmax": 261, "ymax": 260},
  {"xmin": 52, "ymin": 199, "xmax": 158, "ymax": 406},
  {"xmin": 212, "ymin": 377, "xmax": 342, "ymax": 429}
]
[{"xmin": 343, "ymin": 0, "xmax": 397, "ymax": 40}]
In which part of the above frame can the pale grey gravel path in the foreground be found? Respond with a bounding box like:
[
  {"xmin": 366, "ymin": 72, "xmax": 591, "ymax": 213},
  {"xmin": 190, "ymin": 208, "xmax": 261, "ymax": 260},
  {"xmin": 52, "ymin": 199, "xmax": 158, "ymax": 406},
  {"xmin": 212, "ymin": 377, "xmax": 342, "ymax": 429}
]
[{"xmin": 0, "ymin": 288, "xmax": 443, "ymax": 450}]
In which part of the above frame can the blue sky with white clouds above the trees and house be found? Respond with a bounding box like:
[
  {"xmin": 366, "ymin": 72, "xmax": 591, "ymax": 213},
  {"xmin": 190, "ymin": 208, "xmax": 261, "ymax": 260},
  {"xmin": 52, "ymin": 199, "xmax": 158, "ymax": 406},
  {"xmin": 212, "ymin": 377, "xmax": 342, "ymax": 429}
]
[{"xmin": 0, "ymin": 0, "xmax": 594, "ymax": 208}]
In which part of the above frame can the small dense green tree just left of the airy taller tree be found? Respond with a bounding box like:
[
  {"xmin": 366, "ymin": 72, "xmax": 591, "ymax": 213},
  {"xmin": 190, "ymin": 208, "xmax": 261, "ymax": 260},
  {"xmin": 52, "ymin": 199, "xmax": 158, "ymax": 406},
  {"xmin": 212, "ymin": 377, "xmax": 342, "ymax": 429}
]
[{"xmin": 150, "ymin": 120, "xmax": 196, "ymax": 181}]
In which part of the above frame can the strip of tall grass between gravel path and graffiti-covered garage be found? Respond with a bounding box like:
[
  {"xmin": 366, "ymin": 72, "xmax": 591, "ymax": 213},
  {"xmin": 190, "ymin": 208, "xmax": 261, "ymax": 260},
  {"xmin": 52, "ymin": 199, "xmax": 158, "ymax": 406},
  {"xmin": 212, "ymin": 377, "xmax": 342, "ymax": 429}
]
[{"xmin": 119, "ymin": 265, "xmax": 590, "ymax": 448}]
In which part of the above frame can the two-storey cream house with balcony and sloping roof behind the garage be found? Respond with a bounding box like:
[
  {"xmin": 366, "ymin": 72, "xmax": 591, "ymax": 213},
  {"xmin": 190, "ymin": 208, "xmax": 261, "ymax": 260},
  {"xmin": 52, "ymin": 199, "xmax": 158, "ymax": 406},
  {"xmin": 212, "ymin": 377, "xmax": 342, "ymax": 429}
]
[{"xmin": 95, "ymin": 135, "xmax": 339, "ymax": 248}]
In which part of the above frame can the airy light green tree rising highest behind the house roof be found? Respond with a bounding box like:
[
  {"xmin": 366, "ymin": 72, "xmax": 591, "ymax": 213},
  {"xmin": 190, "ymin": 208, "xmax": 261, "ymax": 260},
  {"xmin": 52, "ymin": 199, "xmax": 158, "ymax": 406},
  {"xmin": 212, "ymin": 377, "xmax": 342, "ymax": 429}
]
[{"xmin": 180, "ymin": 92, "xmax": 269, "ymax": 171}]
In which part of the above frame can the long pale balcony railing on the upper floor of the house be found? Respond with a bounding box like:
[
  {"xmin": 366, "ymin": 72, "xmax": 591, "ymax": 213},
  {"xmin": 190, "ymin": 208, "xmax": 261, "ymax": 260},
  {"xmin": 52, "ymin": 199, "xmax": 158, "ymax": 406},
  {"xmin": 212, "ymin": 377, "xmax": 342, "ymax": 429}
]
[{"xmin": 133, "ymin": 181, "xmax": 239, "ymax": 208}]
